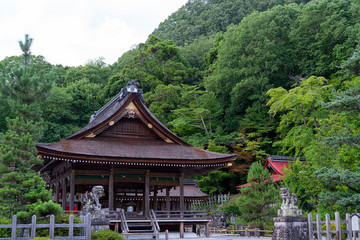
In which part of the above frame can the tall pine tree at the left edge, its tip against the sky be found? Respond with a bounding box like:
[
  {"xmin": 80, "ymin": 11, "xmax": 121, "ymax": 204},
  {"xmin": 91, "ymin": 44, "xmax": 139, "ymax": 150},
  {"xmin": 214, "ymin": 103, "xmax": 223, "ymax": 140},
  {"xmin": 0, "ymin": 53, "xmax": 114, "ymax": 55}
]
[{"xmin": 0, "ymin": 35, "xmax": 61, "ymax": 220}]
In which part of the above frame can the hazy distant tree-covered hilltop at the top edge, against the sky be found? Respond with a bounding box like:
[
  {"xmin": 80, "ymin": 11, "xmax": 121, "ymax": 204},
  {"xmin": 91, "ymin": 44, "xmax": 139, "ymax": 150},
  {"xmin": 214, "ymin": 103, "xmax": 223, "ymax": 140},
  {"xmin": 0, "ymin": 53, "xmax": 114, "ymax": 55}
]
[{"xmin": 152, "ymin": 0, "xmax": 309, "ymax": 46}]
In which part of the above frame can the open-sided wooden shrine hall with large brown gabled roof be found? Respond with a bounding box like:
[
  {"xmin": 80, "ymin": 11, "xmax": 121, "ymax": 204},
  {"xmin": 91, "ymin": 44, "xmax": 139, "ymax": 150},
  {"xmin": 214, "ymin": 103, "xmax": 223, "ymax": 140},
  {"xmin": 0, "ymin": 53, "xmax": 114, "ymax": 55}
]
[{"xmin": 36, "ymin": 81, "xmax": 236, "ymax": 220}]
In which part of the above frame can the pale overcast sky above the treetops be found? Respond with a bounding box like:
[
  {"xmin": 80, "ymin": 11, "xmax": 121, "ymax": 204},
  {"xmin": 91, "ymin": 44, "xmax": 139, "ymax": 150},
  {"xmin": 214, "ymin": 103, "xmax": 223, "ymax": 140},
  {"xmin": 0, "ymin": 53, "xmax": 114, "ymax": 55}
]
[{"xmin": 0, "ymin": 0, "xmax": 188, "ymax": 66}]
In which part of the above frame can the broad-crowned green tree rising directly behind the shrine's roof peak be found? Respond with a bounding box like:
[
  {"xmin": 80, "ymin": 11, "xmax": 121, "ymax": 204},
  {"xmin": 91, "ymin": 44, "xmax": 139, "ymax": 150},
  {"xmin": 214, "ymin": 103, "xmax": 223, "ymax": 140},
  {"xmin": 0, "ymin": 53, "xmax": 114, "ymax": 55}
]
[{"xmin": 104, "ymin": 36, "xmax": 189, "ymax": 98}]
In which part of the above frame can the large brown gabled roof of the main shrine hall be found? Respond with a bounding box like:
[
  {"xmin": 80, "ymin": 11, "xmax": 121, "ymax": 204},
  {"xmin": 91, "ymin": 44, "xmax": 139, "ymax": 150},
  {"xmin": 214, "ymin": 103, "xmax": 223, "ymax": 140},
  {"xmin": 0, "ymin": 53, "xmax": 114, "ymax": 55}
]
[{"xmin": 36, "ymin": 82, "xmax": 236, "ymax": 175}]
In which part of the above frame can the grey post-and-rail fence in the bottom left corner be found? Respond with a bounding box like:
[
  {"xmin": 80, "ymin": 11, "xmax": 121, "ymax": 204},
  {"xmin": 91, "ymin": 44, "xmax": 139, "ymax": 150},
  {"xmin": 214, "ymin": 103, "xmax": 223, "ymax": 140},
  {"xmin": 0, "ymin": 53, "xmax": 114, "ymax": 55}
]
[{"xmin": 0, "ymin": 214, "xmax": 91, "ymax": 240}]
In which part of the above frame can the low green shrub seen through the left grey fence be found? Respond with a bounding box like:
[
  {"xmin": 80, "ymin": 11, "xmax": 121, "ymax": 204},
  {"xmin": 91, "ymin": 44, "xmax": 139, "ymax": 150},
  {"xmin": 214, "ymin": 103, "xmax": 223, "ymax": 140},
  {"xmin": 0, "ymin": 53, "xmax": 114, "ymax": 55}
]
[{"xmin": 36, "ymin": 213, "xmax": 81, "ymax": 237}]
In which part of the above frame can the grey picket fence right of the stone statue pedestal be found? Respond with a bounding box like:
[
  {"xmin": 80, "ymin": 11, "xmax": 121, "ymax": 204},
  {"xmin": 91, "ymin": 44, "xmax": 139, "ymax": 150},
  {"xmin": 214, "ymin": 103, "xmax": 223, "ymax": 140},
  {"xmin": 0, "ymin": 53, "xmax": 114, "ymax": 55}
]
[{"xmin": 308, "ymin": 212, "xmax": 360, "ymax": 240}]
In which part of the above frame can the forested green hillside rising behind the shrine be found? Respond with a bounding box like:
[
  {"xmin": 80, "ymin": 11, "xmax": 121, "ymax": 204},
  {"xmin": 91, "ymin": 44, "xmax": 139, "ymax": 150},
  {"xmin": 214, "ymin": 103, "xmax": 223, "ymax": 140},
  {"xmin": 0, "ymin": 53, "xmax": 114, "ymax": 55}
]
[{"xmin": 0, "ymin": 0, "xmax": 360, "ymax": 218}]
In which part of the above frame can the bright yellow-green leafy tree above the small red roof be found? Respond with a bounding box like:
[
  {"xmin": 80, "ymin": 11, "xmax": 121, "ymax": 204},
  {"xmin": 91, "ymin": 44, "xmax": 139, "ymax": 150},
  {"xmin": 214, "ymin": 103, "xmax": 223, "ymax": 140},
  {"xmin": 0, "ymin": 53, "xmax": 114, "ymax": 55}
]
[{"xmin": 267, "ymin": 76, "xmax": 331, "ymax": 156}]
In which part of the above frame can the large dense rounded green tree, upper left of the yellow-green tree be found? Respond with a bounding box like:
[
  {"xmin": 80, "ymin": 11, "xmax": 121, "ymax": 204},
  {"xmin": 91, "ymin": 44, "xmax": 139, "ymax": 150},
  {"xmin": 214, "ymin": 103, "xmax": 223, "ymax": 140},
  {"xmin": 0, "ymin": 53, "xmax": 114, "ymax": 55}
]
[{"xmin": 204, "ymin": 5, "xmax": 300, "ymax": 131}]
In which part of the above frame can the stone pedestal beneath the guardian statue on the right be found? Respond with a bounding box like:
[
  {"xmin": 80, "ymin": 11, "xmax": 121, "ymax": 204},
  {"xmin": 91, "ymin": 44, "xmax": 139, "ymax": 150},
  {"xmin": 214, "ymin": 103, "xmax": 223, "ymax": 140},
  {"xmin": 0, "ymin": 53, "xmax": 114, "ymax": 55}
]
[{"xmin": 272, "ymin": 216, "xmax": 309, "ymax": 240}]
